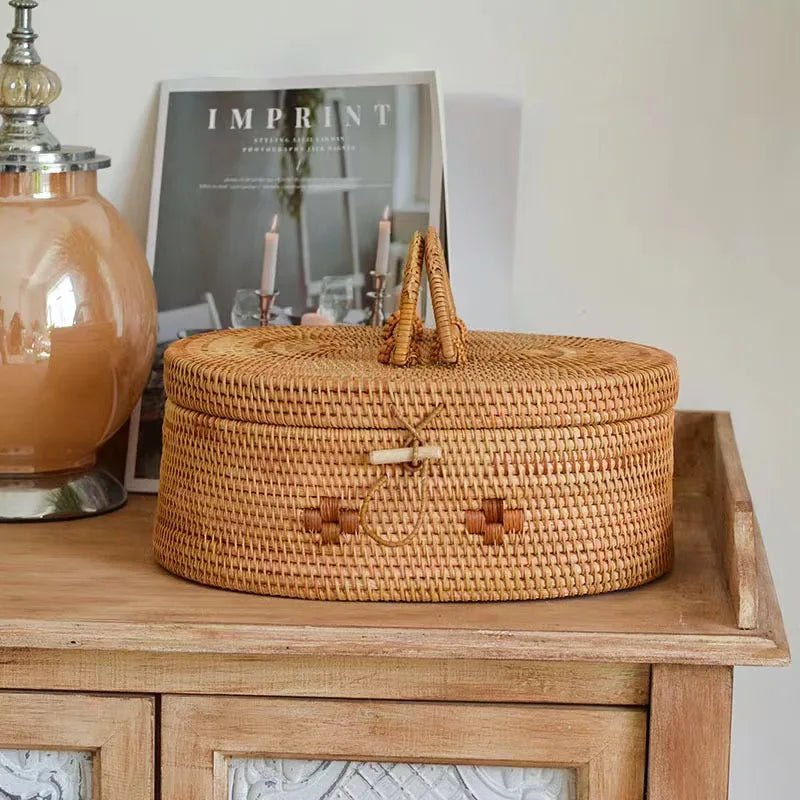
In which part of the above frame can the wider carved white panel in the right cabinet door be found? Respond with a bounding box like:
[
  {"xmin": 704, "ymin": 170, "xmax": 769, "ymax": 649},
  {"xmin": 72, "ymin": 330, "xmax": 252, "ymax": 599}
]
[{"xmin": 228, "ymin": 758, "xmax": 577, "ymax": 800}]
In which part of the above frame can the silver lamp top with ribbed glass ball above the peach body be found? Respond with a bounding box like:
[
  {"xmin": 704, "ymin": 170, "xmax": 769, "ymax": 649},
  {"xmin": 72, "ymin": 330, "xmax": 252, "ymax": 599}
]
[{"xmin": 0, "ymin": 0, "xmax": 110, "ymax": 172}]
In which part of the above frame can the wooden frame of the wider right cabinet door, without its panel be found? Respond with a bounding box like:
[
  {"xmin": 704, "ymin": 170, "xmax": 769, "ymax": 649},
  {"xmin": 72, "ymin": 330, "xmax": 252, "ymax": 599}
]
[{"xmin": 161, "ymin": 695, "xmax": 647, "ymax": 800}]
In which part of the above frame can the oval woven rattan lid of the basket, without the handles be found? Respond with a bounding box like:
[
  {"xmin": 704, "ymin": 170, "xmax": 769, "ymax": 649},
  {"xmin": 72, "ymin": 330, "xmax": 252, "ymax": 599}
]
[{"xmin": 164, "ymin": 326, "xmax": 678, "ymax": 429}]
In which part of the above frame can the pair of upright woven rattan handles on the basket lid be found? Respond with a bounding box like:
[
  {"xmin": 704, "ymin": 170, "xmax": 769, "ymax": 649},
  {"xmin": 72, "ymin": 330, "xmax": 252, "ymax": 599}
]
[{"xmin": 379, "ymin": 227, "xmax": 466, "ymax": 367}]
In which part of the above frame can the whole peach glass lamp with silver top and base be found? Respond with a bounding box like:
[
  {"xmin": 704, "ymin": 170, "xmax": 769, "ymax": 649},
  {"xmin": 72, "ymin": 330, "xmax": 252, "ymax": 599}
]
[{"xmin": 0, "ymin": 0, "xmax": 156, "ymax": 521}]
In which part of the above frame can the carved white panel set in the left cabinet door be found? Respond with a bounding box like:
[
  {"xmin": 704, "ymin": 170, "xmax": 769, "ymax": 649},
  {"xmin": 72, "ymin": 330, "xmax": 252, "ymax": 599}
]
[{"xmin": 0, "ymin": 750, "xmax": 92, "ymax": 800}]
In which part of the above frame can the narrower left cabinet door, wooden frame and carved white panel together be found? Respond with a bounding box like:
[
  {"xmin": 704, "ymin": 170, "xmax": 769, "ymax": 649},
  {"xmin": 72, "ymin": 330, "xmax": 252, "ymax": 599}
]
[{"xmin": 0, "ymin": 692, "xmax": 154, "ymax": 800}]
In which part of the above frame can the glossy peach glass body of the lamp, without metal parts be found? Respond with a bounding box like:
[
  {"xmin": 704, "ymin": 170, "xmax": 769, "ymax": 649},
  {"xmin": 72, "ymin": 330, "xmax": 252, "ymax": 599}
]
[{"xmin": 0, "ymin": 171, "xmax": 156, "ymax": 476}]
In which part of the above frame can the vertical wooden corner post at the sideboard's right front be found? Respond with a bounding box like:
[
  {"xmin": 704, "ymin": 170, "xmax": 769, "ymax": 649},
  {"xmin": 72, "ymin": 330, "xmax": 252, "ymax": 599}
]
[{"xmin": 647, "ymin": 664, "xmax": 733, "ymax": 800}]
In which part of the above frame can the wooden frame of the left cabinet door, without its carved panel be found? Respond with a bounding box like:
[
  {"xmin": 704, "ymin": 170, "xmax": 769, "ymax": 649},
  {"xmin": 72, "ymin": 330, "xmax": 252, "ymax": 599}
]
[{"xmin": 0, "ymin": 691, "xmax": 155, "ymax": 800}]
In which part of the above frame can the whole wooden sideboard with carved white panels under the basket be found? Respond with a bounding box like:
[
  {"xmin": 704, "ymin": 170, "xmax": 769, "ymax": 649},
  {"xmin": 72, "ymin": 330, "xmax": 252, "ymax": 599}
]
[{"xmin": 0, "ymin": 412, "xmax": 789, "ymax": 800}]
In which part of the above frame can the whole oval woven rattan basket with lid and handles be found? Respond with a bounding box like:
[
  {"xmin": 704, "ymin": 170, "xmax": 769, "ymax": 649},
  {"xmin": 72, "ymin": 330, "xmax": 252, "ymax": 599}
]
[{"xmin": 155, "ymin": 228, "xmax": 677, "ymax": 601}]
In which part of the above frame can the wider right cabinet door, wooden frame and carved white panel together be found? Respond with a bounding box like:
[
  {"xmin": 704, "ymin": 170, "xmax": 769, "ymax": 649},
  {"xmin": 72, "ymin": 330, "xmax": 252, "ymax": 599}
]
[{"xmin": 162, "ymin": 696, "xmax": 647, "ymax": 800}]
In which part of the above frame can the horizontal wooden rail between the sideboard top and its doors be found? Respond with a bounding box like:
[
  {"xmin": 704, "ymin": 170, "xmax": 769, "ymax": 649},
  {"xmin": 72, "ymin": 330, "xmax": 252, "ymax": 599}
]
[{"xmin": 0, "ymin": 650, "xmax": 650, "ymax": 706}]
